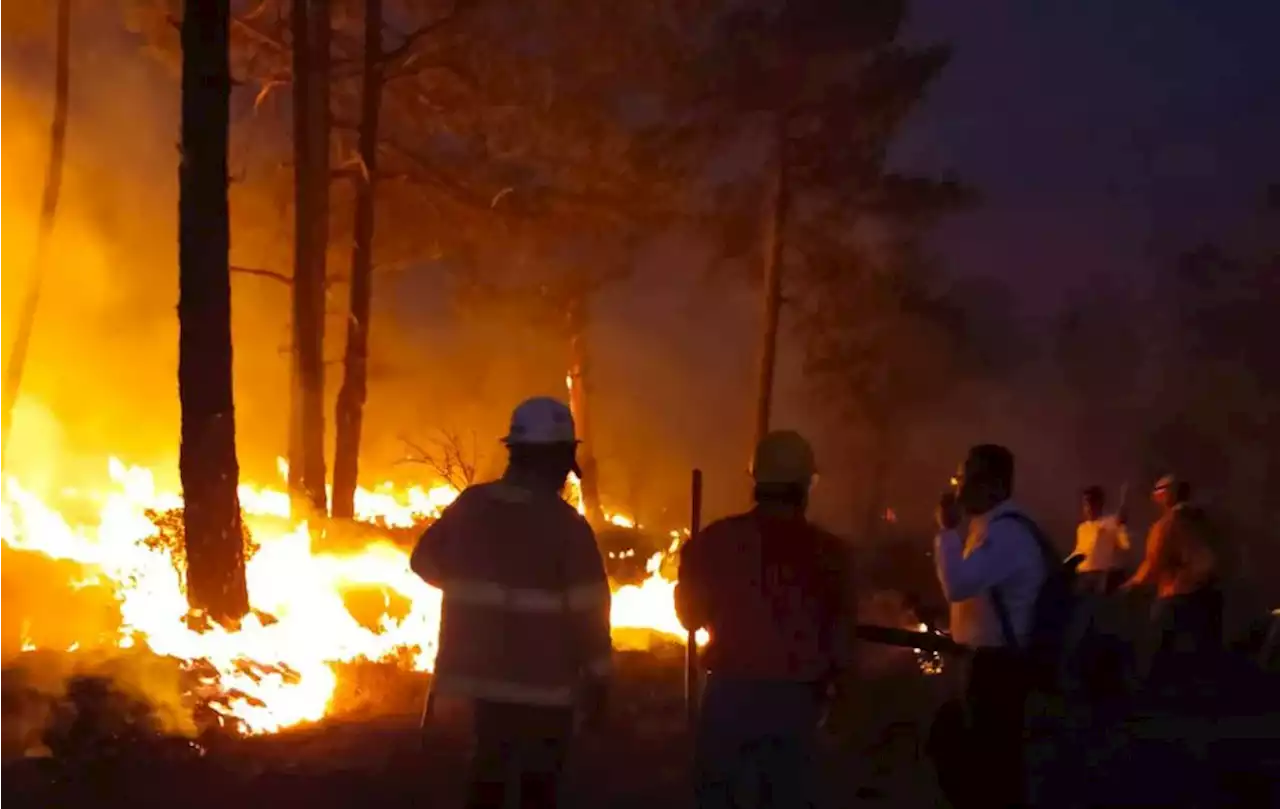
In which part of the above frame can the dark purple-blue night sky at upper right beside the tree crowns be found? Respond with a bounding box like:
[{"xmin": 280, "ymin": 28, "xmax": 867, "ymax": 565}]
[{"xmin": 899, "ymin": 0, "xmax": 1280, "ymax": 308}]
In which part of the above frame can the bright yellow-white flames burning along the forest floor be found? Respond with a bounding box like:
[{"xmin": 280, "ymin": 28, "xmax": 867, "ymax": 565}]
[{"xmin": 0, "ymin": 460, "xmax": 701, "ymax": 733}]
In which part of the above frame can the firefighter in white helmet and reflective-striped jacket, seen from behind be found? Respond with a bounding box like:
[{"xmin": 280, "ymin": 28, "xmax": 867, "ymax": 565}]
[{"xmin": 410, "ymin": 398, "xmax": 612, "ymax": 809}]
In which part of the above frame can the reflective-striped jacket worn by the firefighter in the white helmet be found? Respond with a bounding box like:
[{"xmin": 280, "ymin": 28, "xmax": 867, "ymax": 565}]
[{"xmin": 411, "ymin": 481, "xmax": 612, "ymax": 705}]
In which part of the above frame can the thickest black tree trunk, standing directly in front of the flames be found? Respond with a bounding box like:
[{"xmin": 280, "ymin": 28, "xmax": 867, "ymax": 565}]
[{"xmin": 178, "ymin": 0, "xmax": 248, "ymax": 623}]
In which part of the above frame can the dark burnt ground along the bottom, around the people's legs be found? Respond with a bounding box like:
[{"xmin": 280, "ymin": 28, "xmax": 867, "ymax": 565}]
[{"xmin": 0, "ymin": 649, "xmax": 1280, "ymax": 809}]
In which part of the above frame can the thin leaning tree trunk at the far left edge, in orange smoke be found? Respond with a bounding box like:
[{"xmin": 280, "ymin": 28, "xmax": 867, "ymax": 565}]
[{"xmin": 0, "ymin": 0, "xmax": 72, "ymax": 470}]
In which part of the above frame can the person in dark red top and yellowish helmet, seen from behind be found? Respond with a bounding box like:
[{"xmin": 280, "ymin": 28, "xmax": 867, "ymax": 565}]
[{"xmin": 676, "ymin": 431, "xmax": 852, "ymax": 809}]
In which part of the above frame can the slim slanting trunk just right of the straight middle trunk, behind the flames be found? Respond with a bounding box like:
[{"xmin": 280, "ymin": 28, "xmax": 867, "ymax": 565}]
[{"xmin": 332, "ymin": 0, "xmax": 383, "ymax": 518}]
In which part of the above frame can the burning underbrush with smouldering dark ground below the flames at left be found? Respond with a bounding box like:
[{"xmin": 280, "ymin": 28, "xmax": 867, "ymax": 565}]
[{"xmin": 0, "ymin": 461, "xmax": 701, "ymax": 754}]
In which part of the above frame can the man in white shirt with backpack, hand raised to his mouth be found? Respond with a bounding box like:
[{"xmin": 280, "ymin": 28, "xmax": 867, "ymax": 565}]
[{"xmin": 934, "ymin": 444, "xmax": 1052, "ymax": 809}]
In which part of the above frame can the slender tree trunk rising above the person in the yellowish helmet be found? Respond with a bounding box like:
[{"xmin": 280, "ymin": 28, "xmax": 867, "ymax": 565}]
[{"xmin": 753, "ymin": 114, "xmax": 790, "ymax": 448}]
